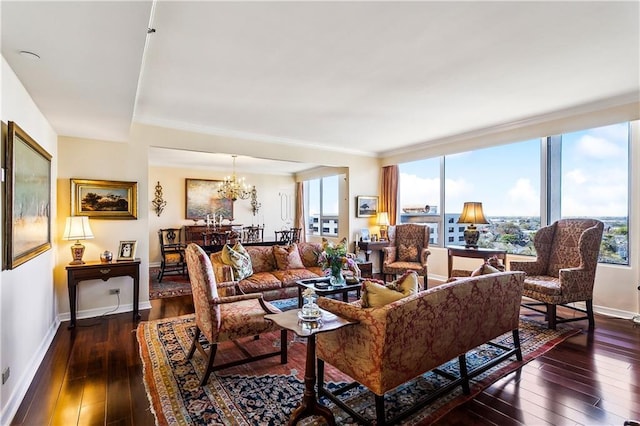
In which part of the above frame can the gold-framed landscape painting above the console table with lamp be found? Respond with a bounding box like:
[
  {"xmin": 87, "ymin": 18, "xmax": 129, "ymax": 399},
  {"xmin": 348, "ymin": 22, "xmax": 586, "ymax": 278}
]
[{"xmin": 71, "ymin": 178, "xmax": 138, "ymax": 219}]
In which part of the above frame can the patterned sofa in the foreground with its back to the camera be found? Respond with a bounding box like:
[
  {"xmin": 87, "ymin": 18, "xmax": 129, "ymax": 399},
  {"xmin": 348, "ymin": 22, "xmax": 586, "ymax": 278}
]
[{"xmin": 316, "ymin": 272, "xmax": 525, "ymax": 425}]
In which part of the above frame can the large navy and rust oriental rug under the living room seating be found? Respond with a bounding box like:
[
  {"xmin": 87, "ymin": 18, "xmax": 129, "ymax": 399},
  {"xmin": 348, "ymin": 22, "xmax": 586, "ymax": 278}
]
[{"xmin": 137, "ymin": 315, "xmax": 580, "ymax": 425}]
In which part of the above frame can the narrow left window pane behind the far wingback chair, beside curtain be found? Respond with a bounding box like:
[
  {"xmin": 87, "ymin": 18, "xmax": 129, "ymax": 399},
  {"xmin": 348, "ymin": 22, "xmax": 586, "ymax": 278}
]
[{"xmin": 398, "ymin": 158, "xmax": 442, "ymax": 245}]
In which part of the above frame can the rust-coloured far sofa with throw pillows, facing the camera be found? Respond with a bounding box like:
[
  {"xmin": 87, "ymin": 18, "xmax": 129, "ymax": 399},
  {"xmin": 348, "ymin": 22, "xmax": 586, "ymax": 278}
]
[{"xmin": 210, "ymin": 243, "xmax": 358, "ymax": 300}]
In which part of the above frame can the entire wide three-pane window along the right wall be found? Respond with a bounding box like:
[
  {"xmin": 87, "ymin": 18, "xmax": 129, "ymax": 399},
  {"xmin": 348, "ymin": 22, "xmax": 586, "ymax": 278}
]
[{"xmin": 399, "ymin": 123, "xmax": 631, "ymax": 264}]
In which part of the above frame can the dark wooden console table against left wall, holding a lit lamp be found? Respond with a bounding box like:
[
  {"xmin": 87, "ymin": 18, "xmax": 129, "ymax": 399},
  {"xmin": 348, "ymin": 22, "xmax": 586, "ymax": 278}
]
[{"xmin": 66, "ymin": 259, "xmax": 140, "ymax": 328}]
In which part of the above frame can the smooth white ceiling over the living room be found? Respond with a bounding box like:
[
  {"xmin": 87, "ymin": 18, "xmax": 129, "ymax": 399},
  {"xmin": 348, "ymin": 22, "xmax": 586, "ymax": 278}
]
[{"xmin": 1, "ymin": 0, "xmax": 640, "ymax": 168}]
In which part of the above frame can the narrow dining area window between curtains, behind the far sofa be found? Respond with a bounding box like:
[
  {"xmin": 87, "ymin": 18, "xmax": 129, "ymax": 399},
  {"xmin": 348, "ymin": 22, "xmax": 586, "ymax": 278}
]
[{"xmin": 304, "ymin": 175, "xmax": 339, "ymax": 237}]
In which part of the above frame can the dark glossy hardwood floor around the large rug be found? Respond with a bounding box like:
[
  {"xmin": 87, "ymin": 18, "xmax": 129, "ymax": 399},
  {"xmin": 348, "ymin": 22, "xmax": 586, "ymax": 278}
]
[{"xmin": 12, "ymin": 296, "xmax": 640, "ymax": 426}]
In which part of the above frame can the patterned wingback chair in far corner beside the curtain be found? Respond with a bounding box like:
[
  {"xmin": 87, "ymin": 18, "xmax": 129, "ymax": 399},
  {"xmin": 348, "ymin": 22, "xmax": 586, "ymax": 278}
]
[{"xmin": 382, "ymin": 223, "xmax": 431, "ymax": 289}]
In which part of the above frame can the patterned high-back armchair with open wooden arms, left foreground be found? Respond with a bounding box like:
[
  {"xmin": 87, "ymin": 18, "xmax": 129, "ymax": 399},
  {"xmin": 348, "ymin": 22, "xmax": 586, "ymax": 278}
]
[{"xmin": 186, "ymin": 243, "xmax": 287, "ymax": 386}]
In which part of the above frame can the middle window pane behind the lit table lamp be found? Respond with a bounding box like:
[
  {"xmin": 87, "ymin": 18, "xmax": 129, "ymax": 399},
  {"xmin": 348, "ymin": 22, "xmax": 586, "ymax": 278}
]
[{"xmin": 444, "ymin": 139, "xmax": 541, "ymax": 254}]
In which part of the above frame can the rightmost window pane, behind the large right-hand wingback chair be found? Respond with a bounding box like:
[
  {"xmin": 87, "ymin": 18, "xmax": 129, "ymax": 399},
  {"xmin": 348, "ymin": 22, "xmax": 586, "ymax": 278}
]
[{"xmin": 549, "ymin": 123, "xmax": 631, "ymax": 264}]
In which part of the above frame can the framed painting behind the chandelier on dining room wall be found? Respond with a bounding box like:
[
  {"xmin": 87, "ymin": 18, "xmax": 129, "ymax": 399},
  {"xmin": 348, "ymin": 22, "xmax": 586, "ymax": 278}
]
[{"xmin": 185, "ymin": 178, "xmax": 233, "ymax": 220}]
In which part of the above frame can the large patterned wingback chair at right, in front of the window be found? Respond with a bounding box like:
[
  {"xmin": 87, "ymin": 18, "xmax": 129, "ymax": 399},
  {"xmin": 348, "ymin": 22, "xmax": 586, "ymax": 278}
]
[{"xmin": 510, "ymin": 219, "xmax": 604, "ymax": 330}]
